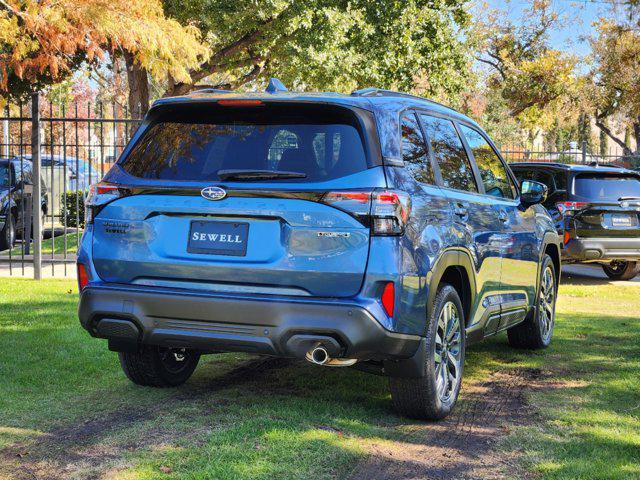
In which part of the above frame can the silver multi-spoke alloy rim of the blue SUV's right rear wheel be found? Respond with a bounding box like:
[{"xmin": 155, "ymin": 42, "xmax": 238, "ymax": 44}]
[{"xmin": 434, "ymin": 302, "xmax": 462, "ymax": 403}]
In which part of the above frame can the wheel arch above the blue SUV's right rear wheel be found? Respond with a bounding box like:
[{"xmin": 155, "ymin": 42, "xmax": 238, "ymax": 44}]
[{"xmin": 427, "ymin": 249, "xmax": 476, "ymax": 330}]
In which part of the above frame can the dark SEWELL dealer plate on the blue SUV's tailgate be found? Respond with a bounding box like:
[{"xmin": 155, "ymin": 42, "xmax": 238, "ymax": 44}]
[{"xmin": 187, "ymin": 220, "xmax": 249, "ymax": 257}]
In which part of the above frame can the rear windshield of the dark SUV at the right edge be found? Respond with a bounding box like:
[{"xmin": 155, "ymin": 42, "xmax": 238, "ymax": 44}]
[{"xmin": 574, "ymin": 174, "xmax": 640, "ymax": 202}]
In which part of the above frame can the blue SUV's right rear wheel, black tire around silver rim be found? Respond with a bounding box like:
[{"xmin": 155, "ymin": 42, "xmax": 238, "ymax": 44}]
[{"xmin": 389, "ymin": 284, "xmax": 465, "ymax": 420}]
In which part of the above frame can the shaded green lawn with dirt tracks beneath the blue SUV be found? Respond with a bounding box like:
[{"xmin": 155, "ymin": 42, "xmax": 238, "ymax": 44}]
[{"xmin": 0, "ymin": 283, "xmax": 640, "ymax": 479}]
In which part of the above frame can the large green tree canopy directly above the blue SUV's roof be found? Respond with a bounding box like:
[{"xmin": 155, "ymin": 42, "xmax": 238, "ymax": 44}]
[{"xmin": 164, "ymin": 0, "xmax": 469, "ymax": 99}]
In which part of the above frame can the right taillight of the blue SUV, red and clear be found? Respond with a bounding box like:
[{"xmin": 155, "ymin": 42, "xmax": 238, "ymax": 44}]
[{"xmin": 322, "ymin": 189, "xmax": 411, "ymax": 235}]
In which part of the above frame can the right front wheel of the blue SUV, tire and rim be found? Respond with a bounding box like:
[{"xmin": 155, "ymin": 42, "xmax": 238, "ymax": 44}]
[{"xmin": 507, "ymin": 254, "xmax": 558, "ymax": 350}]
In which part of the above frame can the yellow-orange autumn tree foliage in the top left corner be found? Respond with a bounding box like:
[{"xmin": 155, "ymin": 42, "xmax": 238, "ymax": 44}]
[{"xmin": 0, "ymin": 0, "xmax": 208, "ymax": 115}]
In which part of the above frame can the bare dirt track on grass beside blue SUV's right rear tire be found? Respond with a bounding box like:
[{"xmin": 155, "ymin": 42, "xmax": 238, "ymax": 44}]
[{"xmin": 351, "ymin": 369, "xmax": 547, "ymax": 480}]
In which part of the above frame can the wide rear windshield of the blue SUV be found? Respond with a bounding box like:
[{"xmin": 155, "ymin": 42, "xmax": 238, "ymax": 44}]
[{"xmin": 121, "ymin": 106, "xmax": 368, "ymax": 182}]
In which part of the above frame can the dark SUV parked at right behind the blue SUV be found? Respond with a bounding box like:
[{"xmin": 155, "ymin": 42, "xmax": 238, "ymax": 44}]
[{"xmin": 511, "ymin": 163, "xmax": 640, "ymax": 280}]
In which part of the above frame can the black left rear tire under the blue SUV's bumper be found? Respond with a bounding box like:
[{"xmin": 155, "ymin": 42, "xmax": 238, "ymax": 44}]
[{"xmin": 118, "ymin": 345, "xmax": 200, "ymax": 388}]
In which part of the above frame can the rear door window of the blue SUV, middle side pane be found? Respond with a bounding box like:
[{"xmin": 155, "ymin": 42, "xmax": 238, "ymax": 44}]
[{"xmin": 420, "ymin": 115, "xmax": 478, "ymax": 192}]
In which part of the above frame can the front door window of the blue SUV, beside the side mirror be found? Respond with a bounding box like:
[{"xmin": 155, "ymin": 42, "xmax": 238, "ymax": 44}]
[{"xmin": 461, "ymin": 125, "xmax": 515, "ymax": 198}]
